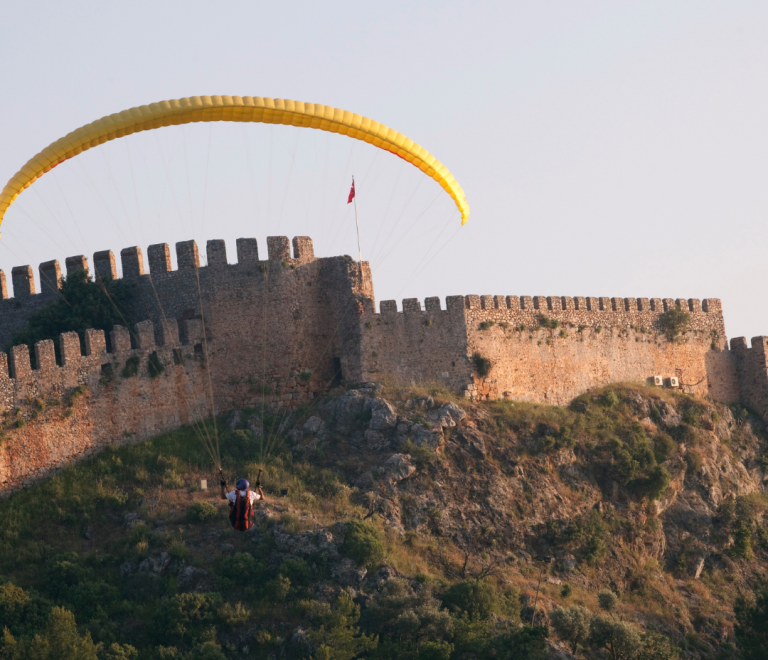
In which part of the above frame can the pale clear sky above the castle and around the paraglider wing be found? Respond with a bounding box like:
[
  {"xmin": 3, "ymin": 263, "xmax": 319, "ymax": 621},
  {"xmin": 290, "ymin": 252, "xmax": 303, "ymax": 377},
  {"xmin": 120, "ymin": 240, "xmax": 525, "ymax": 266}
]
[{"xmin": 0, "ymin": 0, "xmax": 768, "ymax": 346}]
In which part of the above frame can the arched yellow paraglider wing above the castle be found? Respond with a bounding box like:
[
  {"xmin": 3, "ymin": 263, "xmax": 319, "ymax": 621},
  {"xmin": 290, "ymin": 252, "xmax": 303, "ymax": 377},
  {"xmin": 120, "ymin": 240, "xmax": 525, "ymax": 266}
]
[{"xmin": 0, "ymin": 96, "xmax": 469, "ymax": 225}]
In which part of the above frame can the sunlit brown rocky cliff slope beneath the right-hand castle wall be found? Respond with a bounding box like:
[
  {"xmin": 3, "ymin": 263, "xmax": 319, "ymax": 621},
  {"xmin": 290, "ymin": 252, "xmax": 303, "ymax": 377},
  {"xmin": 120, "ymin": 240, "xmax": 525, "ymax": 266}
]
[{"xmin": 260, "ymin": 385, "xmax": 768, "ymax": 657}]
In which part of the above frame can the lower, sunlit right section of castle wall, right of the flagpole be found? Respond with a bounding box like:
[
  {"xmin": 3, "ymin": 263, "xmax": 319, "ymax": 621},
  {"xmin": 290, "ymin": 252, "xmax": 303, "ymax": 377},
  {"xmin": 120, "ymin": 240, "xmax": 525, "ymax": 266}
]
[{"xmin": 361, "ymin": 296, "xmax": 739, "ymax": 405}]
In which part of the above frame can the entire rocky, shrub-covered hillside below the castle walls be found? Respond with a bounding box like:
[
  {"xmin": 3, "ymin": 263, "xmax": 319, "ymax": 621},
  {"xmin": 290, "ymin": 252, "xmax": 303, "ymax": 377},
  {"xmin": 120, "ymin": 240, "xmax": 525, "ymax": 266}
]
[{"xmin": 0, "ymin": 386, "xmax": 768, "ymax": 660}]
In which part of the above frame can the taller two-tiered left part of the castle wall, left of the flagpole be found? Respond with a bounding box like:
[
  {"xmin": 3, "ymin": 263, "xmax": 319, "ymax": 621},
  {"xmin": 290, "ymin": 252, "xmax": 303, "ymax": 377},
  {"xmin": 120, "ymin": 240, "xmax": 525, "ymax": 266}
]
[{"xmin": 0, "ymin": 237, "xmax": 373, "ymax": 492}]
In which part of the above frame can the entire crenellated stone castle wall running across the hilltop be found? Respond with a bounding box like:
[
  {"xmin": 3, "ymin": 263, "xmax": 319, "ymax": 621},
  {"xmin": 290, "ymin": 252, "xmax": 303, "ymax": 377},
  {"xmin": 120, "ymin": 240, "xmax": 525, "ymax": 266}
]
[{"xmin": 0, "ymin": 236, "xmax": 768, "ymax": 494}]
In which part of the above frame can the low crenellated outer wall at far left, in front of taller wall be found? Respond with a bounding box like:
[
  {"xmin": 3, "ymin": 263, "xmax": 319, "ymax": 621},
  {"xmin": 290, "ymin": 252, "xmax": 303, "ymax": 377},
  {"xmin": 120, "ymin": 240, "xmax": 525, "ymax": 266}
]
[{"xmin": 0, "ymin": 321, "xmax": 211, "ymax": 493}]
